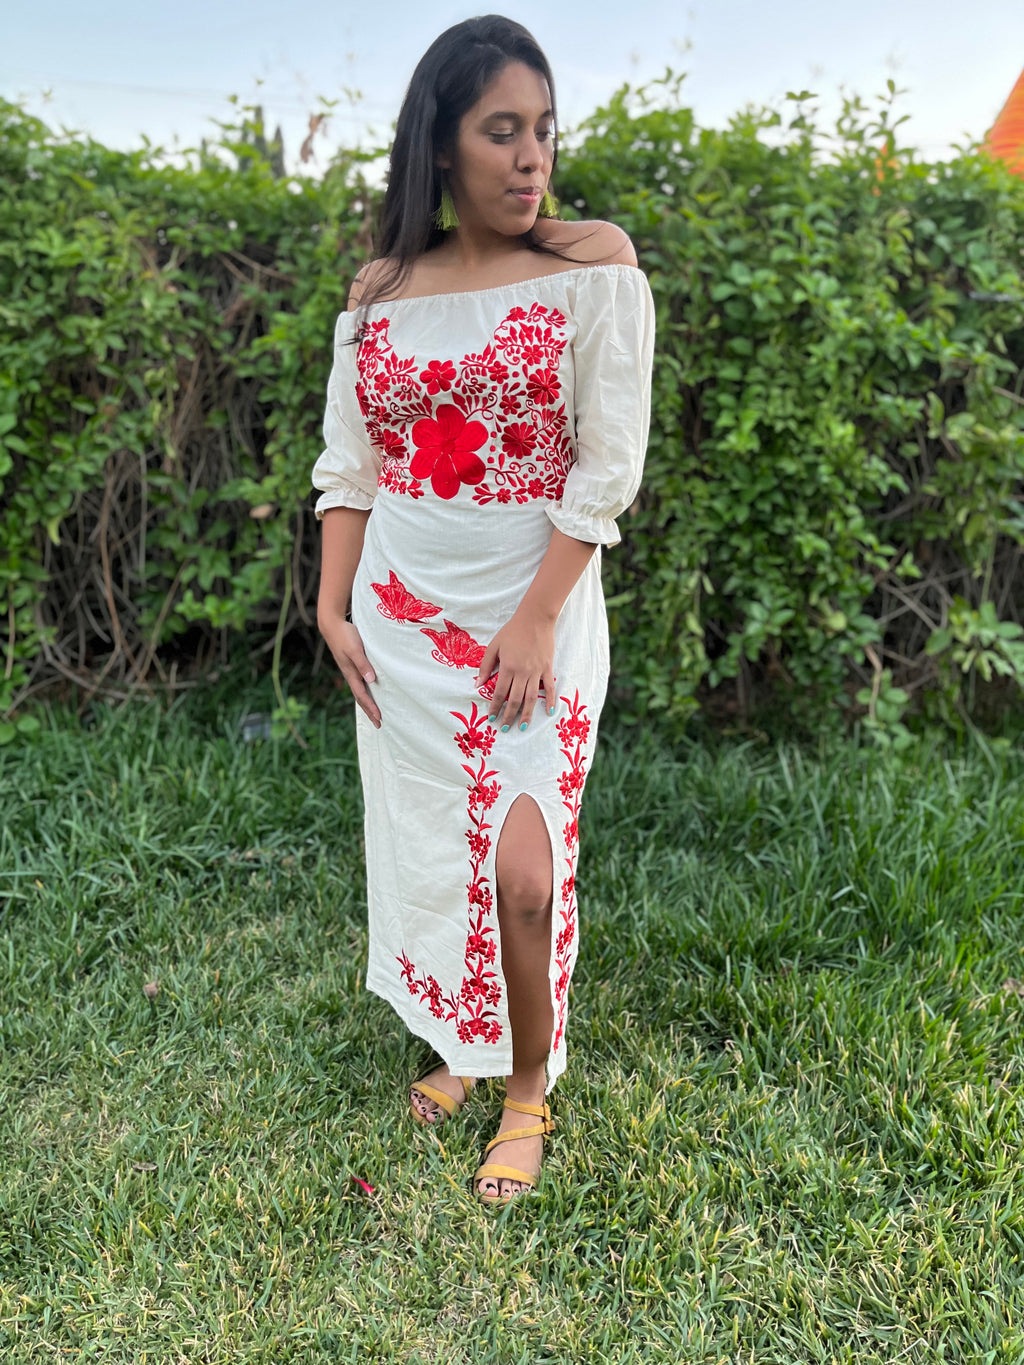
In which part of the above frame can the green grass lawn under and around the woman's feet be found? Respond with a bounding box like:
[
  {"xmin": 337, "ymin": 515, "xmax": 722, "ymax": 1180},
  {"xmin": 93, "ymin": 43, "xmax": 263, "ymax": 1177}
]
[{"xmin": 0, "ymin": 691, "xmax": 1024, "ymax": 1365}]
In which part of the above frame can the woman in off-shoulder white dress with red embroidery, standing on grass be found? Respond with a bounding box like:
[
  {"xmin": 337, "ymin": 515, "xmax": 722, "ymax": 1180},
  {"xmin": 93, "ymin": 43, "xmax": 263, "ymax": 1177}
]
[{"xmin": 313, "ymin": 15, "xmax": 653, "ymax": 1203}]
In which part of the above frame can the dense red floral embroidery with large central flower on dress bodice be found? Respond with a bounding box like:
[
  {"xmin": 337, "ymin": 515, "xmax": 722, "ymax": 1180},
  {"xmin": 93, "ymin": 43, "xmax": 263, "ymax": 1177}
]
[{"xmin": 355, "ymin": 303, "xmax": 573, "ymax": 504}]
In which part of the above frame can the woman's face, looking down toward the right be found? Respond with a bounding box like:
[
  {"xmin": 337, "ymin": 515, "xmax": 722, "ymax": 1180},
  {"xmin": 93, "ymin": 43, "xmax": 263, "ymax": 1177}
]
[{"xmin": 440, "ymin": 61, "xmax": 554, "ymax": 236}]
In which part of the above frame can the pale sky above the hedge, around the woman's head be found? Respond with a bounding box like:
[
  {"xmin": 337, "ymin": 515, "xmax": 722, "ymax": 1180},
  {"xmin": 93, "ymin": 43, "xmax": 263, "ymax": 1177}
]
[{"xmin": 0, "ymin": 0, "xmax": 1024, "ymax": 164}]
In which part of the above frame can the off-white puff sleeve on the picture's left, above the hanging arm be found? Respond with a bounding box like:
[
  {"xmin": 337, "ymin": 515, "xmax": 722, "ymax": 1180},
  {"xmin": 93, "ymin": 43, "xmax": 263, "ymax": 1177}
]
[{"xmin": 313, "ymin": 313, "xmax": 381, "ymax": 520}]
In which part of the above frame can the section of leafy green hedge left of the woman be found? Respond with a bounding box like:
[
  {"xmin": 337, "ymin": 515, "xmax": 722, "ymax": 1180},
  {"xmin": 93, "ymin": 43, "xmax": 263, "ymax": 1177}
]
[{"xmin": 0, "ymin": 104, "xmax": 370, "ymax": 711}]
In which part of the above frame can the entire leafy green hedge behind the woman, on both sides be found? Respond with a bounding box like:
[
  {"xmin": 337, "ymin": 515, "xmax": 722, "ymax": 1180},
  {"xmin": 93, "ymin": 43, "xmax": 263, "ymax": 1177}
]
[{"xmin": 0, "ymin": 79, "xmax": 1024, "ymax": 743}]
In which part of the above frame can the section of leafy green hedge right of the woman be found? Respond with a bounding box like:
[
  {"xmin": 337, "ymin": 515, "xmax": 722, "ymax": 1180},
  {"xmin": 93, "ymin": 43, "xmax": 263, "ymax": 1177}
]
[{"xmin": 560, "ymin": 81, "xmax": 1024, "ymax": 717}]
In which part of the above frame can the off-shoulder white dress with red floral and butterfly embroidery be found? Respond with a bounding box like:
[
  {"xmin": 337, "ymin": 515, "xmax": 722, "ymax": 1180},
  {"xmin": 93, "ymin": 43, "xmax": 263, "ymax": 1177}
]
[{"xmin": 313, "ymin": 265, "xmax": 654, "ymax": 1091}]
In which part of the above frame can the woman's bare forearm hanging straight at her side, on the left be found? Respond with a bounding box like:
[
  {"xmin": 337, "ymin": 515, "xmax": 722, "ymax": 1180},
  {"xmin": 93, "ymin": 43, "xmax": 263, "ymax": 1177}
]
[{"xmin": 317, "ymin": 508, "xmax": 381, "ymax": 729}]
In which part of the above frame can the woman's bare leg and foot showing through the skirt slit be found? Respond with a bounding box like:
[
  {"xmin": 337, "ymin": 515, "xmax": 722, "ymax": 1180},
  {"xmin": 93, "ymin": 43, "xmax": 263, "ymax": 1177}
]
[{"xmin": 477, "ymin": 796, "xmax": 554, "ymax": 1198}]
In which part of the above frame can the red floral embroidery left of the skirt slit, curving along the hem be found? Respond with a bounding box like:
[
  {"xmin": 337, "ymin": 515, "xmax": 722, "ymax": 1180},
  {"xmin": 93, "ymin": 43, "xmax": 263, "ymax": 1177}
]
[{"xmin": 397, "ymin": 702, "xmax": 502, "ymax": 1043}]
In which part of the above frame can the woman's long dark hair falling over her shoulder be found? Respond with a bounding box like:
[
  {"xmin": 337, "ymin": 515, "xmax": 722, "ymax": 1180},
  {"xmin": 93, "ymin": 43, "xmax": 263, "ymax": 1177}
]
[{"xmin": 359, "ymin": 14, "xmax": 572, "ymax": 311}]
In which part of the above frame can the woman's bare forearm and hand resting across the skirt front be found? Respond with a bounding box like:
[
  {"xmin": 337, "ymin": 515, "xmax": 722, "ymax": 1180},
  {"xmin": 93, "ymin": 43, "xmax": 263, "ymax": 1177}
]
[{"xmin": 477, "ymin": 528, "xmax": 597, "ymax": 729}]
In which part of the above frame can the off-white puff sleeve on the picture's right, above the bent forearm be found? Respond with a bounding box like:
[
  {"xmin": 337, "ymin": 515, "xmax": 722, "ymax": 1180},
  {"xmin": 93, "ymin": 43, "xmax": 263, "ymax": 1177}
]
[{"xmin": 546, "ymin": 265, "xmax": 654, "ymax": 546}]
